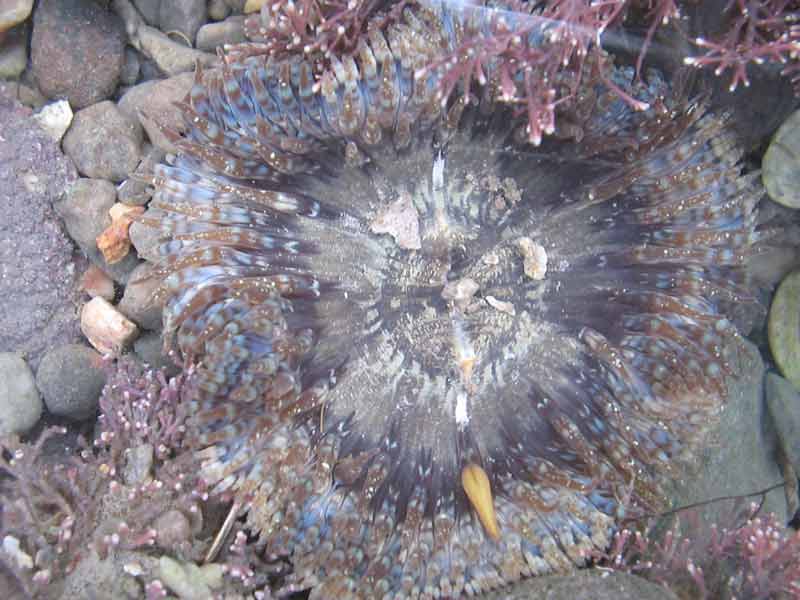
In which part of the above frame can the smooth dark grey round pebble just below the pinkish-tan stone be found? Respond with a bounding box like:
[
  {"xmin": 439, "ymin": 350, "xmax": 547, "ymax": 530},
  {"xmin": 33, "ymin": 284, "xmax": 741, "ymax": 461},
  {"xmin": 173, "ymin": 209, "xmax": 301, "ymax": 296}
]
[{"xmin": 36, "ymin": 344, "xmax": 106, "ymax": 421}]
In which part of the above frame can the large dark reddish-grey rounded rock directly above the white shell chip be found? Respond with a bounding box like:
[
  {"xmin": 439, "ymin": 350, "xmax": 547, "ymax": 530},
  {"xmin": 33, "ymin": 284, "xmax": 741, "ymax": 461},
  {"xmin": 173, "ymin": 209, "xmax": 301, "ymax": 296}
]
[{"xmin": 31, "ymin": 0, "xmax": 125, "ymax": 110}]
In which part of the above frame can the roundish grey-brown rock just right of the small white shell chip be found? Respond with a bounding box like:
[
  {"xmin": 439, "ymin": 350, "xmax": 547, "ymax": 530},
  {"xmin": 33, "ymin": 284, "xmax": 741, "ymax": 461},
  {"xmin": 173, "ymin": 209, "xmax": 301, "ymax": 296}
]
[{"xmin": 64, "ymin": 101, "xmax": 142, "ymax": 181}]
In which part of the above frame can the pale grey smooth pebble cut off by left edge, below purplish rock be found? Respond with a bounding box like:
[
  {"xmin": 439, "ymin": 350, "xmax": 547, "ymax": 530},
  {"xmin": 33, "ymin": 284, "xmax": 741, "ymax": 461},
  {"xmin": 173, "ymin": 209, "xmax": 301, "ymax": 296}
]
[{"xmin": 0, "ymin": 352, "xmax": 42, "ymax": 436}]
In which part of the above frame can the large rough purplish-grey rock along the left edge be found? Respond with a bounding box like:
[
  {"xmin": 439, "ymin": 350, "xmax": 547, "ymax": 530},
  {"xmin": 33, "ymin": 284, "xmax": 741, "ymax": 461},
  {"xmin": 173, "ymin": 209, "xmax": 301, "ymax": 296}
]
[{"xmin": 0, "ymin": 92, "xmax": 80, "ymax": 369}]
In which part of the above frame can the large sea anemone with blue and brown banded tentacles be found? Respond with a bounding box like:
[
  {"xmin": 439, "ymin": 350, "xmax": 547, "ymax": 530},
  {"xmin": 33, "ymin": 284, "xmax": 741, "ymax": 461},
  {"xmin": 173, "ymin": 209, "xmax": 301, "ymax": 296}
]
[{"xmin": 143, "ymin": 3, "xmax": 760, "ymax": 598}]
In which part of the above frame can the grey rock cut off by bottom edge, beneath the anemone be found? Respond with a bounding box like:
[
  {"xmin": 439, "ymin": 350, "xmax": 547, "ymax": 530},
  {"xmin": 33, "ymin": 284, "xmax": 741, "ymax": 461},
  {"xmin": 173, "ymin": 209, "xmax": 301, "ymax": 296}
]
[{"xmin": 479, "ymin": 570, "xmax": 678, "ymax": 600}]
